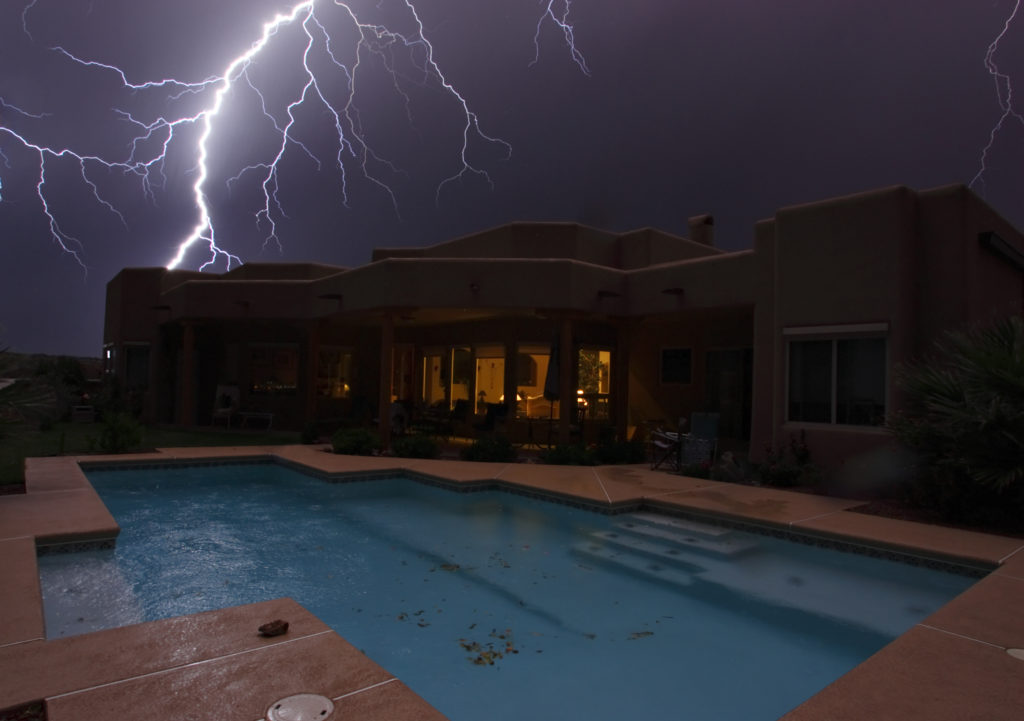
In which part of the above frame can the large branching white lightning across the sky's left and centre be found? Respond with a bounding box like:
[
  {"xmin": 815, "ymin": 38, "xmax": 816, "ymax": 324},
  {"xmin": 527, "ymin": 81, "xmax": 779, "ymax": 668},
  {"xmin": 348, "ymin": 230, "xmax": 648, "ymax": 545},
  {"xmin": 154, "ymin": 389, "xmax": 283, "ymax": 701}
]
[{"xmin": 0, "ymin": 0, "xmax": 590, "ymax": 269}]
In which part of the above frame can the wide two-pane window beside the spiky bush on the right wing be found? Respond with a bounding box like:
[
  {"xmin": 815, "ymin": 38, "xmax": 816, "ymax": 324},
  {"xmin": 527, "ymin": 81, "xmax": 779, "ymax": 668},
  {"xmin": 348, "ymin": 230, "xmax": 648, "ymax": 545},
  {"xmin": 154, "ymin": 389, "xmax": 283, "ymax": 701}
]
[{"xmin": 787, "ymin": 338, "xmax": 886, "ymax": 426}]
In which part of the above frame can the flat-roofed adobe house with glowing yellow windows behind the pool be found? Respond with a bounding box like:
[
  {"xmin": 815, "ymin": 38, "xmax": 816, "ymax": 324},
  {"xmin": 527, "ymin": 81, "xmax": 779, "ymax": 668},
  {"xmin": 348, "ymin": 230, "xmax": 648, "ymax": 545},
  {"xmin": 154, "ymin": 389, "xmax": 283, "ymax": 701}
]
[{"xmin": 103, "ymin": 185, "xmax": 1024, "ymax": 467}]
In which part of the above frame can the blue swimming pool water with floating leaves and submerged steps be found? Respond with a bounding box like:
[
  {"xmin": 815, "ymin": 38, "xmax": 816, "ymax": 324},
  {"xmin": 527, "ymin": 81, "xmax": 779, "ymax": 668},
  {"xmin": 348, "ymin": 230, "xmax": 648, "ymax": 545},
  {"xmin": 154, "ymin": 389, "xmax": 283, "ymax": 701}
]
[{"xmin": 40, "ymin": 464, "xmax": 973, "ymax": 721}]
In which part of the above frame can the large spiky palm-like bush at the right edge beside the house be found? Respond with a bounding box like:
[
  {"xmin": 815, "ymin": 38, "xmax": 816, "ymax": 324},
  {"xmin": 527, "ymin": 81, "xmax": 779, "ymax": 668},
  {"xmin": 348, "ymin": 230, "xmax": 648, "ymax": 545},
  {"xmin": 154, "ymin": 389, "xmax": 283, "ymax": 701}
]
[{"xmin": 888, "ymin": 316, "xmax": 1024, "ymax": 527}]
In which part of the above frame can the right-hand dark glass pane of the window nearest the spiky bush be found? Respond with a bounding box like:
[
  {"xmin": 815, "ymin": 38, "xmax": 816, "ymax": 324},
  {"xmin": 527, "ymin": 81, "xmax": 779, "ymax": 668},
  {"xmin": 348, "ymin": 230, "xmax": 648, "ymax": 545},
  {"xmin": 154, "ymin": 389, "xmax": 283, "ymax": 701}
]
[{"xmin": 836, "ymin": 338, "xmax": 886, "ymax": 426}]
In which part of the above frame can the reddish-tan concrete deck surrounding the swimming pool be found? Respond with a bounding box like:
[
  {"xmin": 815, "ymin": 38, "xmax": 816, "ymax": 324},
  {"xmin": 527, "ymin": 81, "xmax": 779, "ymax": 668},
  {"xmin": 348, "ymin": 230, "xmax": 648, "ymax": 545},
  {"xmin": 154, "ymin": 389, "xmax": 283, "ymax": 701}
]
[{"xmin": 0, "ymin": 446, "xmax": 1024, "ymax": 721}]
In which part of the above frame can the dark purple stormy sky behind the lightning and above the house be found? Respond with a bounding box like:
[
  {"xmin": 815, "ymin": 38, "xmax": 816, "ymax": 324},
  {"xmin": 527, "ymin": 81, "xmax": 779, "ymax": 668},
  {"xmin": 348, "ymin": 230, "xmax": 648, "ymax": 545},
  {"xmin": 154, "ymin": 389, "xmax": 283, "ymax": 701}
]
[{"xmin": 0, "ymin": 0, "xmax": 1024, "ymax": 355}]
